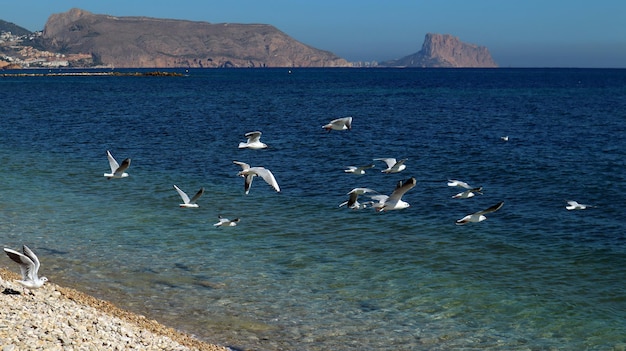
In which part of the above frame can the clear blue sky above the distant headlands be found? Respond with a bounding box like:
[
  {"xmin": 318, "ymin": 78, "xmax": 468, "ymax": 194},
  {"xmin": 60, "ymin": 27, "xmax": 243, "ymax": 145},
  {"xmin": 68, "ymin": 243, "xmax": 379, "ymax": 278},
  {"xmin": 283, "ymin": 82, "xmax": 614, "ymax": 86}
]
[{"xmin": 0, "ymin": 0, "xmax": 626, "ymax": 68}]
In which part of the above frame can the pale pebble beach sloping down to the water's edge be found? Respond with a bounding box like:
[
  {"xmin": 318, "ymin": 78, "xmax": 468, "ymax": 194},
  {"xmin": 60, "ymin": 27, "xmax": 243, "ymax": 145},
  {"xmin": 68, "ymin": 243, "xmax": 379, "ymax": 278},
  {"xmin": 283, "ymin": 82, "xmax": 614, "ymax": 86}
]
[{"xmin": 0, "ymin": 267, "xmax": 230, "ymax": 351}]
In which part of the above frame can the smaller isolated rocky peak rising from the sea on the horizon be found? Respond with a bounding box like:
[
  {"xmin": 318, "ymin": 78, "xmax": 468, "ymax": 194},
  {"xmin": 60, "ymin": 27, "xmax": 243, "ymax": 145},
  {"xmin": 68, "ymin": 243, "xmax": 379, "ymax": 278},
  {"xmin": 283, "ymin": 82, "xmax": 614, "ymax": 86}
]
[{"xmin": 380, "ymin": 33, "xmax": 498, "ymax": 67}]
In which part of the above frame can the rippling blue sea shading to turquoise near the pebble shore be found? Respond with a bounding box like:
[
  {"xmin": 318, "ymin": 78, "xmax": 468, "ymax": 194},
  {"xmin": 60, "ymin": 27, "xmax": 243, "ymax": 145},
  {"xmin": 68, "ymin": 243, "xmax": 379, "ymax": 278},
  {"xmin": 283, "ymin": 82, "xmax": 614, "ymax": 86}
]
[{"xmin": 0, "ymin": 68, "xmax": 626, "ymax": 351}]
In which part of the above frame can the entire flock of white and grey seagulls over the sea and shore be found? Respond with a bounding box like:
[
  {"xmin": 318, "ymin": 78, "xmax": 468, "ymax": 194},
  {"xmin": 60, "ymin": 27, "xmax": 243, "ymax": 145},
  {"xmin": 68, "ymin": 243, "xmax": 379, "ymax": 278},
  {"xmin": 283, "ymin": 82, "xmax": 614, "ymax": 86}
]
[{"xmin": 4, "ymin": 117, "xmax": 595, "ymax": 294}]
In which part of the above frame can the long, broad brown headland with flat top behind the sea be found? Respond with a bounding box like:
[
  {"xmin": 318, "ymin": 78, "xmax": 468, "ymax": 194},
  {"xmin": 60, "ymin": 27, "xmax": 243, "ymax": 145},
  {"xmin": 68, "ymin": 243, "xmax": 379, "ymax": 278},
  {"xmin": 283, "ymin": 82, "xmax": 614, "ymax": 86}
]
[{"xmin": 42, "ymin": 9, "xmax": 350, "ymax": 68}]
